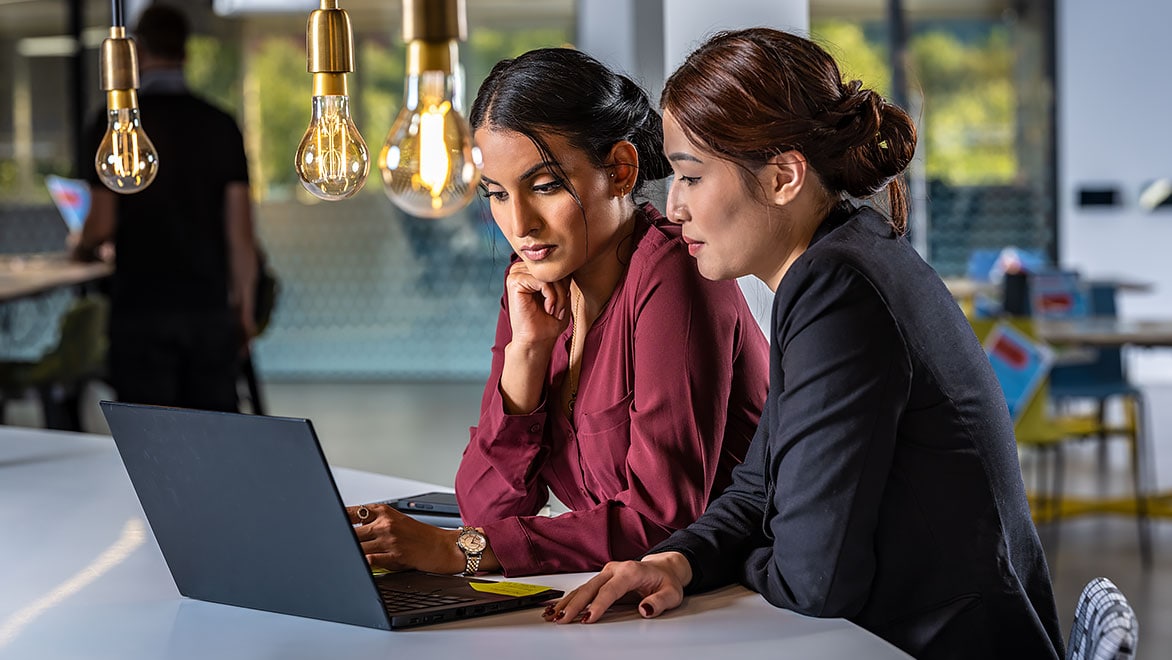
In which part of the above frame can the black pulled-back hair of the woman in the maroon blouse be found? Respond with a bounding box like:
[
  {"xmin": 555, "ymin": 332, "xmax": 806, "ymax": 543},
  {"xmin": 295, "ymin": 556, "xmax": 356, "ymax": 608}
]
[{"xmin": 469, "ymin": 48, "xmax": 670, "ymax": 197}]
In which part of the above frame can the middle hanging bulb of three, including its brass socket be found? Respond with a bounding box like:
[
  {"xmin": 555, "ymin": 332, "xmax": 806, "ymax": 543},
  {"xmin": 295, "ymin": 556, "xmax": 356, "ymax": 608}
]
[{"xmin": 293, "ymin": 0, "xmax": 370, "ymax": 202}]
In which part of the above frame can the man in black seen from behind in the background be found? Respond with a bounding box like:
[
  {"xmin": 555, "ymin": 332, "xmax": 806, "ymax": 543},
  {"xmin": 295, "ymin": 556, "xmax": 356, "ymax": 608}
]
[{"xmin": 75, "ymin": 5, "xmax": 257, "ymax": 410}]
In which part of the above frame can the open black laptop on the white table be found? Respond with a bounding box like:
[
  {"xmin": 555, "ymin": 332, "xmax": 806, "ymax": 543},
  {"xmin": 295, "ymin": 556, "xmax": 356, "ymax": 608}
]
[{"xmin": 101, "ymin": 401, "xmax": 561, "ymax": 630}]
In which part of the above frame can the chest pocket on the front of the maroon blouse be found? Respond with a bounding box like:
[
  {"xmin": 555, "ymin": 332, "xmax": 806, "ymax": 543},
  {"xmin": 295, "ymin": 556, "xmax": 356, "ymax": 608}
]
[{"xmin": 577, "ymin": 392, "xmax": 635, "ymax": 501}]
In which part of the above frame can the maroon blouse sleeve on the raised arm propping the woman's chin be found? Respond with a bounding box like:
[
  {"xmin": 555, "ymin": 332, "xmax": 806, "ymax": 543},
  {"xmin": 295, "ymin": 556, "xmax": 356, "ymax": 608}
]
[{"xmin": 456, "ymin": 283, "xmax": 548, "ymax": 527}]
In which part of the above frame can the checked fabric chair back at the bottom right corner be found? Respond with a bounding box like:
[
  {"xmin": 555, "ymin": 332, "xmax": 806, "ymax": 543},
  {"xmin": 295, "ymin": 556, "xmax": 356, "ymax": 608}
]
[{"xmin": 1067, "ymin": 578, "xmax": 1139, "ymax": 660}]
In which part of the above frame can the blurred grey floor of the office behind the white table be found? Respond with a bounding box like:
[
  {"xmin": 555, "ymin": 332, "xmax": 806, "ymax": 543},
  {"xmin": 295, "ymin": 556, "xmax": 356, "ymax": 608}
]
[{"xmin": 8, "ymin": 383, "xmax": 1172, "ymax": 658}]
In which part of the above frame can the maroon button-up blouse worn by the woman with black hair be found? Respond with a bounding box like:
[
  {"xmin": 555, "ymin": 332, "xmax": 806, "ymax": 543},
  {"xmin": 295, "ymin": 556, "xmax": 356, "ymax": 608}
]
[{"xmin": 456, "ymin": 205, "xmax": 769, "ymax": 576}]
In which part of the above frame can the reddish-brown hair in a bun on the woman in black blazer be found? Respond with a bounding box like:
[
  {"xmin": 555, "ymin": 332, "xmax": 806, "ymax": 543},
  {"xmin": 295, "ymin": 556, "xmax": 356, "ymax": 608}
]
[{"xmin": 661, "ymin": 28, "xmax": 915, "ymax": 233}]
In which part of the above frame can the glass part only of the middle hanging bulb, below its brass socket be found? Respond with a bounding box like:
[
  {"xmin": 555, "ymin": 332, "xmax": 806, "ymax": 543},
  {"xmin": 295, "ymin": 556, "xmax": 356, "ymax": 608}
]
[{"xmin": 297, "ymin": 95, "xmax": 370, "ymax": 202}]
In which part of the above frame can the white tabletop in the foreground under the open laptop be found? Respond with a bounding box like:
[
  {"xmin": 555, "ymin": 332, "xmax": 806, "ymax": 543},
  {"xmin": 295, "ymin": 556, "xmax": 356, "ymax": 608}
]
[{"xmin": 0, "ymin": 427, "xmax": 907, "ymax": 660}]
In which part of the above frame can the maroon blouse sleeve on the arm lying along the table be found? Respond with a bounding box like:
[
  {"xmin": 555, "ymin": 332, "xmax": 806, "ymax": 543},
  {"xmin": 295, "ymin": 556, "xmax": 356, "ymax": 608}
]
[{"xmin": 475, "ymin": 245, "xmax": 768, "ymax": 576}]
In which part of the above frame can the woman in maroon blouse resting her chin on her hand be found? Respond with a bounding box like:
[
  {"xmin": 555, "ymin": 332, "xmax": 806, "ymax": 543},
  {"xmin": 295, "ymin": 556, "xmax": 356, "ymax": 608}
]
[{"xmin": 350, "ymin": 48, "xmax": 769, "ymax": 576}]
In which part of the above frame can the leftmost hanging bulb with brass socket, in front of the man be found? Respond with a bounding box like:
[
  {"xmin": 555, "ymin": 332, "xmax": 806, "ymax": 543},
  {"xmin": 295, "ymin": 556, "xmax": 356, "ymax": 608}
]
[{"xmin": 94, "ymin": 25, "xmax": 158, "ymax": 195}]
